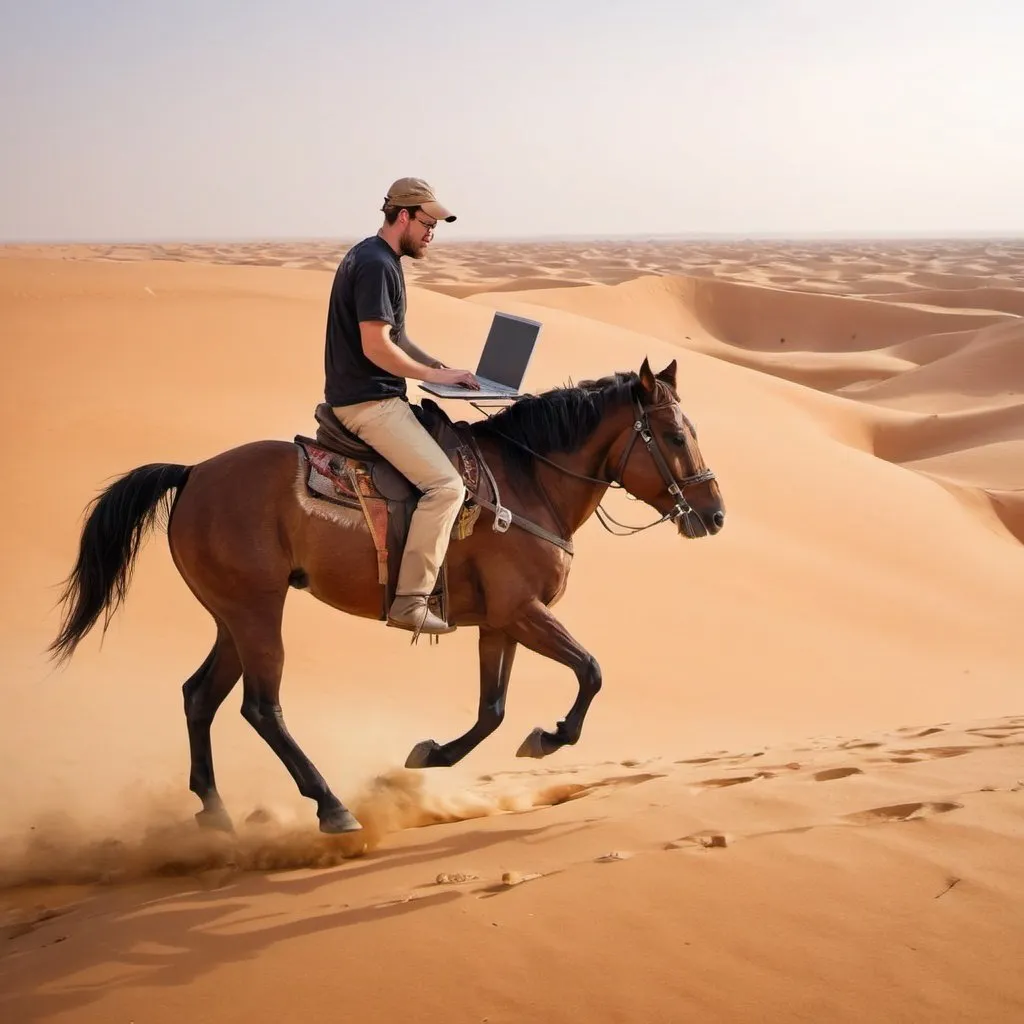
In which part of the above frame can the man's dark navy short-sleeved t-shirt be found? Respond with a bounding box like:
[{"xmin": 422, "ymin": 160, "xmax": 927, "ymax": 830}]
[{"xmin": 324, "ymin": 234, "xmax": 408, "ymax": 406}]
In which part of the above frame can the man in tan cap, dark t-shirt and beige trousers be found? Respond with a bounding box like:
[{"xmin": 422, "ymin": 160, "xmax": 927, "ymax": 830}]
[{"xmin": 325, "ymin": 178, "xmax": 480, "ymax": 633}]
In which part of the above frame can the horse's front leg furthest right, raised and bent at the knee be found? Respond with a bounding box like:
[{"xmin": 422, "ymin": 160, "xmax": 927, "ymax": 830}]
[{"xmin": 507, "ymin": 600, "xmax": 601, "ymax": 758}]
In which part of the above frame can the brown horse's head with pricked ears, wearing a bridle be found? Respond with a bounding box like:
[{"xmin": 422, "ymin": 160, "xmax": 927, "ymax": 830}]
[{"xmin": 608, "ymin": 358, "xmax": 725, "ymax": 538}]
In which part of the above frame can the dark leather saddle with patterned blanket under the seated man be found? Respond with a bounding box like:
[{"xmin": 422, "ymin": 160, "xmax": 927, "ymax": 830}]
[{"xmin": 295, "ymin": 398, "xmax": 489, "ymax": 620}]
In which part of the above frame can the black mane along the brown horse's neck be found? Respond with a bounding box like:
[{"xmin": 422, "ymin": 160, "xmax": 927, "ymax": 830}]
[{"xmin": 473, "ymin": 372, "xmax": 640, "ymax": 467}]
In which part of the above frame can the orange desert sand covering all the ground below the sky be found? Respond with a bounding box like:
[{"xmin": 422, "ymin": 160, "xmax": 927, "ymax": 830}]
[{"xmin": 0, "ymin": 240, "xmax": 1024, "ymax": 1024}]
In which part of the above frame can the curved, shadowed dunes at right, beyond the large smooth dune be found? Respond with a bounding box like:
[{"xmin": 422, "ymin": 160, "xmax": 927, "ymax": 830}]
[{"xmin": 466, "ymin": 260, "xmax": 1024, "ymax": 557}]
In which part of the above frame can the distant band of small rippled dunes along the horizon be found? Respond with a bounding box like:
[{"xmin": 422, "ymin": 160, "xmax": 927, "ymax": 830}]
[{"xmin": 12, "ymin": 232, "xmax": 1024, "ymax": 295}]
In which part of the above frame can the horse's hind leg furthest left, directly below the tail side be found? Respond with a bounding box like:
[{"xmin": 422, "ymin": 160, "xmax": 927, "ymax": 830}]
[{"xmin": 181, "ymin": 623, "xmax": 242, "ymax": 831}]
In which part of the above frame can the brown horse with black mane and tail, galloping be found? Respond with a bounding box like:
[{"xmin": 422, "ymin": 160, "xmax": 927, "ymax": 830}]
[{"xmin": 49, "ymin": 359, "xmax": 725, "ymax": 833}]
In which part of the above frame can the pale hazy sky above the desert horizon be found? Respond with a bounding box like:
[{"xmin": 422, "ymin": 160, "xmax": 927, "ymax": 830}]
[{"xmin": 0, "ymin": 0, "xmax": 1024, "ymax": 242}]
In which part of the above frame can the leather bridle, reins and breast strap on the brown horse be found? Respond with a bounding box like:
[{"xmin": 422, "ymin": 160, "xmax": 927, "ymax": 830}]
[{"xmin": 477, "ymin": 398, "xmax": 715, "ymax": 555}]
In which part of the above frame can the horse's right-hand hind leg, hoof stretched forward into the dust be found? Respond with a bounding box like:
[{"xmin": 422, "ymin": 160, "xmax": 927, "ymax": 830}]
[{"xmin": 232, "ymin": 598, "xmax": 362, "ymax": 834}]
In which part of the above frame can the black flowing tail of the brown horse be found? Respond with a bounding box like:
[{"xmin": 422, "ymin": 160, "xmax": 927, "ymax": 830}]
[{"xmin": 47, "ymin": 463, "xmax": 190, "ymax": 662}]
